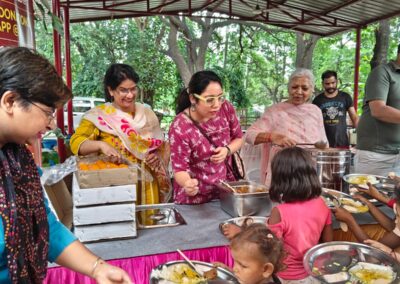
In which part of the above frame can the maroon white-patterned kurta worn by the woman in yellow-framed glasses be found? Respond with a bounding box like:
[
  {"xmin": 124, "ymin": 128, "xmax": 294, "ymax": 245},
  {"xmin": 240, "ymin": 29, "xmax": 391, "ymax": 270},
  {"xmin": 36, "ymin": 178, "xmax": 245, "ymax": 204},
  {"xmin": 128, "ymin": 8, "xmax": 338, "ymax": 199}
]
[{"xmin": 169, "ymin": 101, "xmax": 243, "ymax": 204}]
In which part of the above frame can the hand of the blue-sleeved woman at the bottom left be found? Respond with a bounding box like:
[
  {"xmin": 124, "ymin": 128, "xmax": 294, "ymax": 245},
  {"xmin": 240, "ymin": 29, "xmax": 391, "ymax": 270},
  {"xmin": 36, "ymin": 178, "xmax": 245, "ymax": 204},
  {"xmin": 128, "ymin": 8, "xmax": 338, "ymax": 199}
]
[{"xmin": 93, "ymin": 260, "xmax": 133, "ymax": 284}]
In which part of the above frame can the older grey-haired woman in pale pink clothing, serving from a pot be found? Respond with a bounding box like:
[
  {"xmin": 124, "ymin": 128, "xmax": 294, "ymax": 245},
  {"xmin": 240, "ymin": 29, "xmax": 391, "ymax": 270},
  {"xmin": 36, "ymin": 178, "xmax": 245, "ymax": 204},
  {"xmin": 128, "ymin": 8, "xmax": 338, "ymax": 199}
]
[{"xmin": 246, "ymin": 69, "xmax": 328, "ymax": 186}]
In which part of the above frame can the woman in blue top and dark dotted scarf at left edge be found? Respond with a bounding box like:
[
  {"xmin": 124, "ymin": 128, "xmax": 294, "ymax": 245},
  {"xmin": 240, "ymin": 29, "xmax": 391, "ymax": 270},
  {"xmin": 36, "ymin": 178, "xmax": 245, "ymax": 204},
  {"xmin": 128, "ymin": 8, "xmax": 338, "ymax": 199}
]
[{"xmin": 0, "ymin": 47, "xmax": 131, "ymax": 284}]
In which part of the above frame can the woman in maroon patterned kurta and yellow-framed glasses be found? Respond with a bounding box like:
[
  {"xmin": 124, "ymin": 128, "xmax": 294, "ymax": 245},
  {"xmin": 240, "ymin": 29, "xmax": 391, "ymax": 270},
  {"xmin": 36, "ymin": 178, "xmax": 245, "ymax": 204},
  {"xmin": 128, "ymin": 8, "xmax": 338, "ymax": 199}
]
[{"xmin": 169, "ymin": 71, "xmax": 243, "ymax": 204}]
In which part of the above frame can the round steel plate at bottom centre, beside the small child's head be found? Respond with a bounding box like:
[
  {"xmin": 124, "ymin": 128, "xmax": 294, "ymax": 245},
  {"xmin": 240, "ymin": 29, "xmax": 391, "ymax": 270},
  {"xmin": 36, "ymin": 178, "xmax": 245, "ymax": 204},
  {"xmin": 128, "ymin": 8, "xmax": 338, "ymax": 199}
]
[{"xmin": 150, "ymin": 260, "xmax": 239, "ymax": 284}]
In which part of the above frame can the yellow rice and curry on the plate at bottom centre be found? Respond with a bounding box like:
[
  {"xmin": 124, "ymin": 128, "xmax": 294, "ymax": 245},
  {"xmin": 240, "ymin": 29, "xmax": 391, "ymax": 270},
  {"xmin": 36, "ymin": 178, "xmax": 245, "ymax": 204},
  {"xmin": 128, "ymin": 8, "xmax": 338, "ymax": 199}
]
[{"xmin": 152, "ymin": 263, "xmax": 217, "ymax": 284}]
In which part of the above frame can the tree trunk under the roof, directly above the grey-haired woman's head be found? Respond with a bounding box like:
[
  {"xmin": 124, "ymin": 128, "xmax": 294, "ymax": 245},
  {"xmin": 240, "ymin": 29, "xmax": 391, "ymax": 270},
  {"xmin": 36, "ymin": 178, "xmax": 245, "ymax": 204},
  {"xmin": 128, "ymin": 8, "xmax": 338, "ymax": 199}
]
[{"xmin": 296, "ymin": 32, "xmax": 320, "ymax": 69}]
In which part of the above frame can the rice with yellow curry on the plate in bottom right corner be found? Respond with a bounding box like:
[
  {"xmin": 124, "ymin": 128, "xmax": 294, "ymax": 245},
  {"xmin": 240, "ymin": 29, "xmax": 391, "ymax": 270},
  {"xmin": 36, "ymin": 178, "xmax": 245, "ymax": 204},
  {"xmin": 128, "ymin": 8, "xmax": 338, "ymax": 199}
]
[{"xmin": 349, "ymin": 262, "xmax": 396, "ymax": 284}]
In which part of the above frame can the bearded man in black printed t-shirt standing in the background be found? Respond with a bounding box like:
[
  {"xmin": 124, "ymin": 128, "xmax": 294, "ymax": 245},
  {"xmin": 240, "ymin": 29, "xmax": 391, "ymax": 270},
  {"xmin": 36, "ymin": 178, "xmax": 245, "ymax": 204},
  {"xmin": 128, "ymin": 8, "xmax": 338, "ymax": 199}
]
[{"xmin": 313, "ymin": 70, "xmax": 358, "ymax": 148}]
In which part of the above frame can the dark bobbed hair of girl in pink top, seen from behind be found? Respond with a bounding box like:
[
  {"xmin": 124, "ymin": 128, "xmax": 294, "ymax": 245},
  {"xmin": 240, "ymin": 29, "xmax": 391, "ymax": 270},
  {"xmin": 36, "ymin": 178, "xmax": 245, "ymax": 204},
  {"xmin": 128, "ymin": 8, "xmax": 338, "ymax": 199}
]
[{"xmin": 269, "ymin": 147, "xmax": 321, "ymax": 202}]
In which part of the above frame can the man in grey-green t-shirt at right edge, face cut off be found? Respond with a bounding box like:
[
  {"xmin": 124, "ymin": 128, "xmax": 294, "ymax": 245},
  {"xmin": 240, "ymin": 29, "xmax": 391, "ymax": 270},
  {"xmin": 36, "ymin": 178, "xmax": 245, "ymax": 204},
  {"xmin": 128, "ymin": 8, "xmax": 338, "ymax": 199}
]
[{"xmin": 354, "ymin": 45, "xmax": 400, "ymax": 176}]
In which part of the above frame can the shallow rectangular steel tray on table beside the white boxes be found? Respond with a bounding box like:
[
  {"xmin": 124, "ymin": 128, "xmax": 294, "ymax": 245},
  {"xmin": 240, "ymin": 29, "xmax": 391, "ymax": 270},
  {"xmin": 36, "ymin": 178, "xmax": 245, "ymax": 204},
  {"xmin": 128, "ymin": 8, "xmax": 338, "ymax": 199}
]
[{"xmin": 136, "ymin": 203, "xmax": 186, "ymax": 229}]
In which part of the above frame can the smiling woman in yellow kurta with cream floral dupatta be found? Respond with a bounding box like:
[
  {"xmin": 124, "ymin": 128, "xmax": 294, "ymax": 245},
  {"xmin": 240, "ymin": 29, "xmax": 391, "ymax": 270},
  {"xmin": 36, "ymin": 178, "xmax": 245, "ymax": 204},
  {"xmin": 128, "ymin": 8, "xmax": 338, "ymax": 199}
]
[{"xmin": 70, "ymin": 64, "xmax": 171, "ymax": 204}]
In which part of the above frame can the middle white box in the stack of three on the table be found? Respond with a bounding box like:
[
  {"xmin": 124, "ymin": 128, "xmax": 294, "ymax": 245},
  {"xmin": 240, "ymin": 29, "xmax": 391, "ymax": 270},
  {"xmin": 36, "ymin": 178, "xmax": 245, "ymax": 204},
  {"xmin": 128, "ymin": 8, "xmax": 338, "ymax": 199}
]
[{"xmin": 73, "ymin": 203, "xmax": 135, "ymax": 226}]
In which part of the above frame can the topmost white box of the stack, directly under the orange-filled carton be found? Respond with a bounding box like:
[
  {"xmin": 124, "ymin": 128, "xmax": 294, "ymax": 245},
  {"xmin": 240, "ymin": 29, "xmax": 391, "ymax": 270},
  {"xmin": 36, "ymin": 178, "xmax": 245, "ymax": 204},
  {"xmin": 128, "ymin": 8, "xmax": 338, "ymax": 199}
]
[{"xmin": 72, "ymin": 174, "xmax": 136, "ymax": 207}]
